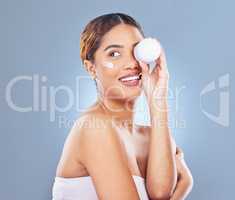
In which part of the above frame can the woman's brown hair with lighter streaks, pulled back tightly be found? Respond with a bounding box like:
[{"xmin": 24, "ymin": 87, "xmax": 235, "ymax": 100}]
[{"xmin": 80, "ymin": 13, "xmax": 144, "ymax": 62}]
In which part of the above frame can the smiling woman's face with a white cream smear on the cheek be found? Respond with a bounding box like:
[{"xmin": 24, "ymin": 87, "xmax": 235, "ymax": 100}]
[{"xmin": 94, "ymin": 24, "xmax": 143, "ymax": 100}]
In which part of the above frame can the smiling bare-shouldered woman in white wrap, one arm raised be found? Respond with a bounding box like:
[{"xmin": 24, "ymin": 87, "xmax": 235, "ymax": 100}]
[{"xmin": 53, "ymin": 13, "xmax": 193, "ymax": 200}]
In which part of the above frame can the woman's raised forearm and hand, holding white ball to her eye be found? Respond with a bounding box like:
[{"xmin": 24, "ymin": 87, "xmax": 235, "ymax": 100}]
[{"xmin": 140, "ymin": 47, "xmax": 177, "ymax": 200}]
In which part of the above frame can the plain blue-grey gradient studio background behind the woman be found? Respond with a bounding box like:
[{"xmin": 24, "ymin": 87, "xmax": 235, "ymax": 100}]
[{"xmin": 0, "ymin": 0, "xmax": 235, "ymax": 200}]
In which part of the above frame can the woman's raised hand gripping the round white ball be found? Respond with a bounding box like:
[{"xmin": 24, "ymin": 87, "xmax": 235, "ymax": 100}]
[{"xmin": 139, "ymin": 43, "xmax": 169, "ymax": 107}]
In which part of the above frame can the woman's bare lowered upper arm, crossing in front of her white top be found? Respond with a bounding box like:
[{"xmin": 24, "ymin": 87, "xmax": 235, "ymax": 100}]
[{"xmin": 79, "ymin": 115, "xmax": 139, "ymax": 200}]
